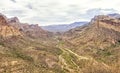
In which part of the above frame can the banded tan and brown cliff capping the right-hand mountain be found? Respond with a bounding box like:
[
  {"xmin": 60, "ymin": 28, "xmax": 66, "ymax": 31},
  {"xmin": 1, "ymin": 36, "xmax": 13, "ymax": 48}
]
[{"xmin": 91, "ymin": 15, "xmax": 120, "ymax": 32}]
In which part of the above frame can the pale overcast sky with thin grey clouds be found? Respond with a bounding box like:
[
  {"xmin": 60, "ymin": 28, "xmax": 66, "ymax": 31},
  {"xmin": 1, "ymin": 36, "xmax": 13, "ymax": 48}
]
[{"xmin": 0, "ymin": 0, "xmax": 120, "ymax": 26}]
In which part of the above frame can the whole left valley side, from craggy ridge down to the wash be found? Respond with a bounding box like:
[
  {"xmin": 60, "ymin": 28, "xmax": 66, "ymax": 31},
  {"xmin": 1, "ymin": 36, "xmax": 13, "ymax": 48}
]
[{"xmin": 0, "ymin": 14, "xmax": 59, "ymax": 73}]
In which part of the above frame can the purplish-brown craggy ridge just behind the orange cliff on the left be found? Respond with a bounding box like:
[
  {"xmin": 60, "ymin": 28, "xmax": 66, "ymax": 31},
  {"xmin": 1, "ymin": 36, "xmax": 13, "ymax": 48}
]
[{"xmin": 8, "ymin": 17, "xmax": 52, "ymax": 38}]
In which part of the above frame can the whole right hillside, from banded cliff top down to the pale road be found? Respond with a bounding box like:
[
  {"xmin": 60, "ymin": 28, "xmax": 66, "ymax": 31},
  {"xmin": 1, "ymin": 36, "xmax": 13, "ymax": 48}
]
[{"xmin": 63, "ymin": 15, "xmax": 120, "ymax": 73}]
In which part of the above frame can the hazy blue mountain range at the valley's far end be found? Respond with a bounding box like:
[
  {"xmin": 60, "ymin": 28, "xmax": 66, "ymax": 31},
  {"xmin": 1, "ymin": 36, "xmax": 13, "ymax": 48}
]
[{"xmin": 41, "ymin": 21, "xmax": 88, "ymax": 32}]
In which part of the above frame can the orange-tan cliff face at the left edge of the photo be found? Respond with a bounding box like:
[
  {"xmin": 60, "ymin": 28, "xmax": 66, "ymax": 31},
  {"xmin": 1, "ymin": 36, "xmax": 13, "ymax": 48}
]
[{"xmin": 0, "ymin": 14, "xmax": 22, "ymax": 38}]
